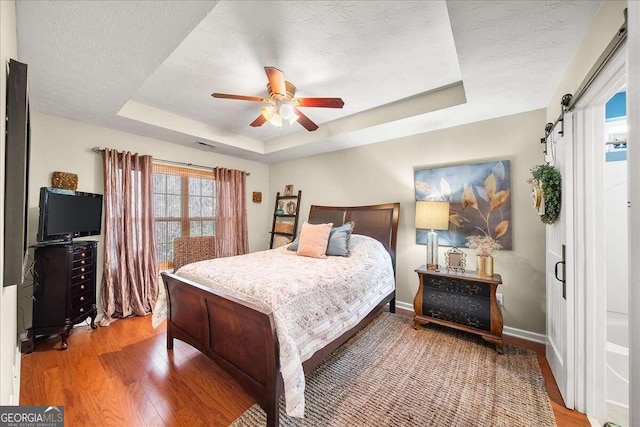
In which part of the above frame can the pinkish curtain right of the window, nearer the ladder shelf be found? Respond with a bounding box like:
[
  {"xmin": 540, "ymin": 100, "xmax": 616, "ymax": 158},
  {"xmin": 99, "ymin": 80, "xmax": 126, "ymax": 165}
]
[{"xmin": 214, "ymin": 168, "xmax": 249, "ymax": 258}]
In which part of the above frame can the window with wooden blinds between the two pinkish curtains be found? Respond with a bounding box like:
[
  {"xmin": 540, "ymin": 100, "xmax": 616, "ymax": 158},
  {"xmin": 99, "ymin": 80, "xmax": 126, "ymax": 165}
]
[{"xmin": 153, "ymin": 163, "xmax": 216, "ymax": 270}]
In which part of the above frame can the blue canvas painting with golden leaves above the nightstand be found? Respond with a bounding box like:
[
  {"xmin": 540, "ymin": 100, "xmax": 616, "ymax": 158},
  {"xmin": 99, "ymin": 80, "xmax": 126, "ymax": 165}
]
[{"xmin": 414, "ymin": 160, "xmax": 513, "ymax": 249}]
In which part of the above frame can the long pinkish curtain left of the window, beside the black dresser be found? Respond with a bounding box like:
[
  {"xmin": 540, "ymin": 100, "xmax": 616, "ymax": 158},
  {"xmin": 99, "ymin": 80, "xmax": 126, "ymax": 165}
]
[{"xmin": 100, "ymin": 149, "xmax": 158, "ymax": 326}]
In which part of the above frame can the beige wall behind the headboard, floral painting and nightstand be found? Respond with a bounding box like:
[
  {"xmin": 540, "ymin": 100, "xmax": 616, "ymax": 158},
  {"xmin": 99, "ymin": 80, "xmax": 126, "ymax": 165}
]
[{"xmin": 269, "ymin": 110, "xmax": 545, "ymax": 334}]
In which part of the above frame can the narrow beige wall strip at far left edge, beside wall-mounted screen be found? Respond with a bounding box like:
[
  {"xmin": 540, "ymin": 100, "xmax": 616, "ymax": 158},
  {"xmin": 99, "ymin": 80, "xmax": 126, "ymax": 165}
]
[{"xmin": 0, "ymin": 1, "xmax": 20, "ymax": 405}]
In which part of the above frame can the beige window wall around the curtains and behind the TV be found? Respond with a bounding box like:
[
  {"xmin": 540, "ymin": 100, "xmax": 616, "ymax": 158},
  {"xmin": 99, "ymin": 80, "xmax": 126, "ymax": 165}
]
[{"xmin": 19, "ymin": 113, "xmax": 272, "ymax": 331}]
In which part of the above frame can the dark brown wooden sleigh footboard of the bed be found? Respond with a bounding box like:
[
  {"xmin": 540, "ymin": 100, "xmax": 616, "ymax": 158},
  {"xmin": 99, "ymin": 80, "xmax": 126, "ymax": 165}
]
[{"xmin": 162, "ymin": 273, "xmax": 282, "ymax": 426}]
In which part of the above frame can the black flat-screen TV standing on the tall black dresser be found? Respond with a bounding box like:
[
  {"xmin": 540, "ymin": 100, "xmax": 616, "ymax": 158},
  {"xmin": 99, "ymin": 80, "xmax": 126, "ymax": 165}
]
[{"xmin": 38, "ymin": 187, "xmax": 102, "ymax": 243}]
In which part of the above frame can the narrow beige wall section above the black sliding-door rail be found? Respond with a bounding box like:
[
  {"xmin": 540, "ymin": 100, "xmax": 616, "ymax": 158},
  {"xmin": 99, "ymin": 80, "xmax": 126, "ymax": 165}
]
[{"xmin": 539, "ymin": 0, "xmax": 627, "ymax": 121}]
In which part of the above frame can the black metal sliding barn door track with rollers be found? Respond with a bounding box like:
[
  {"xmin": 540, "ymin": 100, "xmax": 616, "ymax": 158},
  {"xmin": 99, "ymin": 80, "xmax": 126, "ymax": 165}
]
[{"xmin": 540, "ymin": 8, "xmax": 627, "ymax": 143}]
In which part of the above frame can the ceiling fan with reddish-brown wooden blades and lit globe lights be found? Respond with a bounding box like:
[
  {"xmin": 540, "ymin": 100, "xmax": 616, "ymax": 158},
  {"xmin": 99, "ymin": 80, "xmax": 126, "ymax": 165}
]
[{"xmin": 211, "ymin": 67, "xmax": 344, "ymax": 131}]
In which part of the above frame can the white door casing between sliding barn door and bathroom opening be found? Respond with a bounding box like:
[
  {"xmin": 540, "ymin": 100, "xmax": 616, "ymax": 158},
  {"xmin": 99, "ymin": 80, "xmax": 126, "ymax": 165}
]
[{"xmin": 574, "ymin": 46, "xmax": 626, "ymax": 419}]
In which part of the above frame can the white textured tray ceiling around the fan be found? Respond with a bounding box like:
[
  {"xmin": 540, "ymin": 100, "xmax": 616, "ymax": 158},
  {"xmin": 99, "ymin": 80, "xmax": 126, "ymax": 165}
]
[{"xmin": 17, "ymin": 1, "xmax": 600, "ymax": 162}]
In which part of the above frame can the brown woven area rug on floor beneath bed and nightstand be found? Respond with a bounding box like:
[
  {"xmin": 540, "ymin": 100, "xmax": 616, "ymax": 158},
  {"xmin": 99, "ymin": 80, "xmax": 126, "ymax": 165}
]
[{"xmin": 231, "ymin": 313, "xmax": 556, "ymax": 427}]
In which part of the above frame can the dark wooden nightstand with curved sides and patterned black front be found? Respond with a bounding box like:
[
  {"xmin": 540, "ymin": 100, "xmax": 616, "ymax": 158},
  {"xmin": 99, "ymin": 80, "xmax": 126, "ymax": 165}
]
[{"xmin": 413, "ymin": 265, "xmax": 504, "ymax": 354}]
